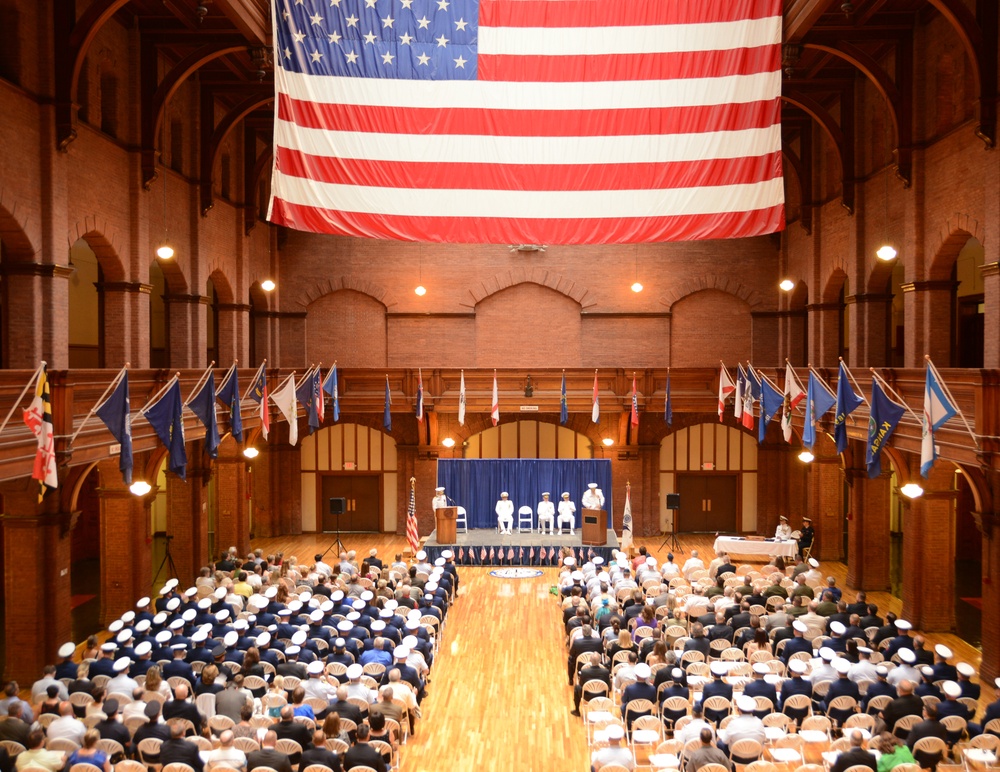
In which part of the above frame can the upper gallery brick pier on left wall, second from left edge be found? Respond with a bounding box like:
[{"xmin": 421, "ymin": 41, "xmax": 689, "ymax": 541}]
[{"xmin": 97, "ymin": 281, "xmax": 152, "ymax": 368}]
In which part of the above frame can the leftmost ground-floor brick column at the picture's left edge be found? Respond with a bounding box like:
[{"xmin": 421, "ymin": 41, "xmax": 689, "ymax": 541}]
[{"xmin": 0, "ymin": 488, "xmax": 72, "ymax": 688}]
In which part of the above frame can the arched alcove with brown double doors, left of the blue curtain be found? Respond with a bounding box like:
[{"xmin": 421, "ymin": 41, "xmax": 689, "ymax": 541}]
[{"xmin": 299, "ymin": 423, "xmax": 397, "ymax": 533}]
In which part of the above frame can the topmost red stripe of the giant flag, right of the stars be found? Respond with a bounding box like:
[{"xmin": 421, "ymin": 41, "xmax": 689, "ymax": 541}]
[{"xmin": 479, "ymin": 0, "xmax": 781, "ymax": 27}]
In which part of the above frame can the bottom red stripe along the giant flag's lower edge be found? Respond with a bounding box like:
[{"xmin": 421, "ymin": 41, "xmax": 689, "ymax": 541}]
[{"xmin": 271, "ymin": 198, "xmax": 785, "ymax": 244}]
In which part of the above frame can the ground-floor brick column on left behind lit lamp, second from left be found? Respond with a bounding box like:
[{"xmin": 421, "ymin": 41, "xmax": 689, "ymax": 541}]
[{"xmin": 97, "ymin": 459, "xmax": 152, "ymax": 625}]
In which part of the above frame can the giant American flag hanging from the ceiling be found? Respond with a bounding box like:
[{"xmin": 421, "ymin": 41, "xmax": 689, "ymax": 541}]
[{"xmin": 269, "ymin": 0, "xmax": 784, "ymax": 244}]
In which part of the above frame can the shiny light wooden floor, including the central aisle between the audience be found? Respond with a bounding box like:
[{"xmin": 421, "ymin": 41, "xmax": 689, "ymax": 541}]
[{"xmin": 253, "ymin": 534, "xmax": 993, "ymax": 772}]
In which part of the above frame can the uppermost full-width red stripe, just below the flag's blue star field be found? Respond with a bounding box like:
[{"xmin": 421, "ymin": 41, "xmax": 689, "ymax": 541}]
[{"xmin": 278, "ymin": 94, "xmax": 781, "ymax": 137}]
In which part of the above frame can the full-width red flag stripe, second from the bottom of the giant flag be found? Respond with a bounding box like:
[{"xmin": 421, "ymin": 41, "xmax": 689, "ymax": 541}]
[{"xmin": 277, "ymin": 147, "xmax": 782, "ymax": 191}]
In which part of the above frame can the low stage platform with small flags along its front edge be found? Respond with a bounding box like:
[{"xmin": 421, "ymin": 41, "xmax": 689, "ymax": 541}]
[{"xmin": 423, "ymin": 528, "xmax": 618, "ymax": 566}]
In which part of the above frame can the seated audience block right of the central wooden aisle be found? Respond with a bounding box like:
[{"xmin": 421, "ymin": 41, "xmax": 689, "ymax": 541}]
[{"xmin": 559, "ymin": 548, "xmax": 1000, "ymax": 772}]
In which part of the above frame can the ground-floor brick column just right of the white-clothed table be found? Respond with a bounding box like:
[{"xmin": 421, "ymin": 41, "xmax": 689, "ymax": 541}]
[{"xmin": 847, "ymin": 463, "xmax": 891, "ymax": 590}]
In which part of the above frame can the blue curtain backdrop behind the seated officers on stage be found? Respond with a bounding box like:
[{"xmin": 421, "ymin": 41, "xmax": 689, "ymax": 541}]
[{"xmin": 437, "ymin": 458, "xmax": 613, "ymax": 529}]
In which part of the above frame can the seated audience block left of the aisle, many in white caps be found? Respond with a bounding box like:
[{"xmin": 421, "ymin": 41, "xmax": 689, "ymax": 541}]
[{"xmin": 0, "ymin": 548, "xmax": 458, "ymax": 772}]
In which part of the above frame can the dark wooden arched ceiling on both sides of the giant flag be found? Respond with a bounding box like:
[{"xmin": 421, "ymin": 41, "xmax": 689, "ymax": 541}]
[{"xmin": 55, "ymin": 0, "xmax": 998, "ymax": 229}]
